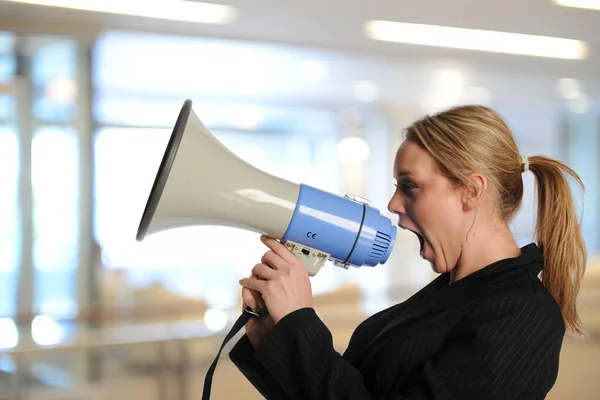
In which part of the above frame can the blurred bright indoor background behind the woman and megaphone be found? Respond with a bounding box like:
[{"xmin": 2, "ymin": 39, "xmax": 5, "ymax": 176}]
[{"xmin": 0, "ymin": 0, "xmax": 600, "ymax": 400}]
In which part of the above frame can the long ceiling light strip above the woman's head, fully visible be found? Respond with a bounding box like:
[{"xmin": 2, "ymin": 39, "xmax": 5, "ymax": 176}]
[{"xmin": 364, "ymin": 20, "xmax": 588, "ymax": 60}]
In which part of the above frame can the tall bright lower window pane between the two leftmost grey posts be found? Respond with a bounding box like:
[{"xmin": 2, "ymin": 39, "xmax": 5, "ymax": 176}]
[{"xmin": 32, "ymin": 127, "xmax": 79, "ymax": 317}]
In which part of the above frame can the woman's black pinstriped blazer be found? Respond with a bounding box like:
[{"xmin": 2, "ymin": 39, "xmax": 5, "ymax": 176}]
[{"xmin": 230, "ymin": 244, "xmax": 565, "ymax": 400}]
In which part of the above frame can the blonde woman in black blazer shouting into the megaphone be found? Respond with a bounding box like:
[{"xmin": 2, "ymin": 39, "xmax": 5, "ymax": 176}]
[{"xmin": 230, "ymin": 106, "xmax": 586, "ymax": 400}]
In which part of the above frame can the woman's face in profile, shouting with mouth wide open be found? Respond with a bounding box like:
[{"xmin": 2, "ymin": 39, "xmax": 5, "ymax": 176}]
[{"xmin": 388, "ymin": 140, "xmax": 473, "ymax": 273}]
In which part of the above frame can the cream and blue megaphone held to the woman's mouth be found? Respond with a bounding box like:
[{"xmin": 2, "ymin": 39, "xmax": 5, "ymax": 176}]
[{"xmin": 136, "ymin": 100, "xmax": 396, "ymax": 276}]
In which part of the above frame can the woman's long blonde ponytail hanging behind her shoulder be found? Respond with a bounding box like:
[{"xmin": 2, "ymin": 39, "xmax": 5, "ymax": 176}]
[{"xmin": 528, "ymin": 156, "xmax": 587, "ymax": 336}]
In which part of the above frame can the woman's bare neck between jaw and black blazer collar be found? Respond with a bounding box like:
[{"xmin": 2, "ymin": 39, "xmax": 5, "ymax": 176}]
[{"xmin": 450, "ymin": 223, "xmax": 521, "ymax": 283}]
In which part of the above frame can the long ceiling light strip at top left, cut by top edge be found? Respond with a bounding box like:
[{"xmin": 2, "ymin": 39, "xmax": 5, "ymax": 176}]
[{"xmin": 7, "ymin": 0, "xmax": 237, "ymax": 24}]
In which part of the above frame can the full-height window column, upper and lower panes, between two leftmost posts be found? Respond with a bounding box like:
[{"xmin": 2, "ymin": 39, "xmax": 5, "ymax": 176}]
[{"xmin": 30, "ymin": 37, "xmax": 80, "ymax": 318}]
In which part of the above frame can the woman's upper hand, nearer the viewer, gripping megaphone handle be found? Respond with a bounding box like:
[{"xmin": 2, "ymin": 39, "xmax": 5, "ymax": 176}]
[{"xmin": 240, "ymin": 236, "xmax": 313, "ymax": 323}]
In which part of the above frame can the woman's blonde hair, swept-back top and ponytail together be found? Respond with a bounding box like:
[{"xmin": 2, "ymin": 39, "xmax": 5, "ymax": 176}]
[{"xmin": 406, "ymin": 106, "xmax": 587, "ymax": 335}]
